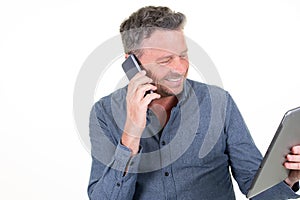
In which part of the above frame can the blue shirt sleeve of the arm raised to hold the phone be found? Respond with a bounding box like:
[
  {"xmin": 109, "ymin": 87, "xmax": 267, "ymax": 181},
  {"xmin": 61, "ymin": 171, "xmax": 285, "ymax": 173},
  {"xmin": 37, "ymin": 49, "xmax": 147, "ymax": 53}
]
[{"xmin": 88, "ymin": 101, "xmax": 141, "ymax": 200}]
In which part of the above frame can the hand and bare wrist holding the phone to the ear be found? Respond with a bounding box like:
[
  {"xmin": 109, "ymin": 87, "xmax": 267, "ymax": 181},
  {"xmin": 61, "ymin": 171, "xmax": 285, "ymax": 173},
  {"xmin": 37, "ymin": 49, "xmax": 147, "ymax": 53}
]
[{"xmin": 121, "ymin": 71, "xmax": 160, "ymax": 154}]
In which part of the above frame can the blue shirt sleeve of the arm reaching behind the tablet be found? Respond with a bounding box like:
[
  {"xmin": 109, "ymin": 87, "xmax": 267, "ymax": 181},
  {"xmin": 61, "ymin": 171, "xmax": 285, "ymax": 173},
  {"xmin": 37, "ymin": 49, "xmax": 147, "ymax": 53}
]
[{"xmin": 225, "ymin": 94, "xmax": 299, "ymax": 200}]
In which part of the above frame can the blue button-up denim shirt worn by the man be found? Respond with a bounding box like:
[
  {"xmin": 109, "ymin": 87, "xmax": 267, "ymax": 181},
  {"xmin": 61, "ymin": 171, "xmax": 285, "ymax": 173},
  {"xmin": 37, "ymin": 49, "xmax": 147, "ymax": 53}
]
[{"xmin": 88, "ymin": 80, "xmax": 299, "ymax": 200}]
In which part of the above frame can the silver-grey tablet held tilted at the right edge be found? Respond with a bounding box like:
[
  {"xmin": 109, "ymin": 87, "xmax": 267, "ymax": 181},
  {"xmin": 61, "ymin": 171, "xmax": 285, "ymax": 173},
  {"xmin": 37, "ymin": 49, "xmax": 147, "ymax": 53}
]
[{"xmin": 247, "ymin": 107, "xmax": 300, "ymax": 198}]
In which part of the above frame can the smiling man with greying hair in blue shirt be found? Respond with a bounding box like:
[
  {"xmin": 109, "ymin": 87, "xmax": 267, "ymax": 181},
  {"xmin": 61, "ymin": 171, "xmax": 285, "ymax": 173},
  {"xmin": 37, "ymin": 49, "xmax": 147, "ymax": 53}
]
[{"xmin": 88, "ymin": 6, "xmax": 300, "ymax": 200}]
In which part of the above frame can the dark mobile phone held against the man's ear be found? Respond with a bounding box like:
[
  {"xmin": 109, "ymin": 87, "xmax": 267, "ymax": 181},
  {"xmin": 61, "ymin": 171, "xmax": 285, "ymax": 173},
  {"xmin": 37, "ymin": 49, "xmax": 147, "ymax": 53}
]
[{"xmin": 122, "ymin": 54, "xmax": 142, "ymax": 80}]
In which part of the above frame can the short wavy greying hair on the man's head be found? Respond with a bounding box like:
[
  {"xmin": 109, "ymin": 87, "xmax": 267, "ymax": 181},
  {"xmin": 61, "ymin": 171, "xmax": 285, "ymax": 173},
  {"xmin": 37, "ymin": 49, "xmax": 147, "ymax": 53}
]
[{"xmin": 120, "ymin": 6, "xmax": 186, "ymax": 57}]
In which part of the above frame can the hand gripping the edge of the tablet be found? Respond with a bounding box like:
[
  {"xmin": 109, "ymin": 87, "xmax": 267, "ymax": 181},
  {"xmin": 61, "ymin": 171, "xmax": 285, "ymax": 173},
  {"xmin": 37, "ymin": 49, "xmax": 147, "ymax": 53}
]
[{"xmin": 284, "ymin": 145, "xmax": 300, "ymax": 187}]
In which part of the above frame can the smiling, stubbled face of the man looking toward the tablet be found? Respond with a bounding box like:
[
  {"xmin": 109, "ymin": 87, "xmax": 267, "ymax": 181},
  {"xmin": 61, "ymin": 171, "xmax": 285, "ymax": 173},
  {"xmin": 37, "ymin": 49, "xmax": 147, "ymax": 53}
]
[{"xmin": 139, "ymin": 30, "xmax": 189, "ymax": 96}]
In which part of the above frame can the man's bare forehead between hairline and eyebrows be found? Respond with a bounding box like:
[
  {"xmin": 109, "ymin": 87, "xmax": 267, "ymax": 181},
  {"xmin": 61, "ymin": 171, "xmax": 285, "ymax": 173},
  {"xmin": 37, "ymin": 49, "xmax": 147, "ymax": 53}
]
[{"xmin": 141, "ymin": 30, "xmax": 187, "ymax": 54}]
